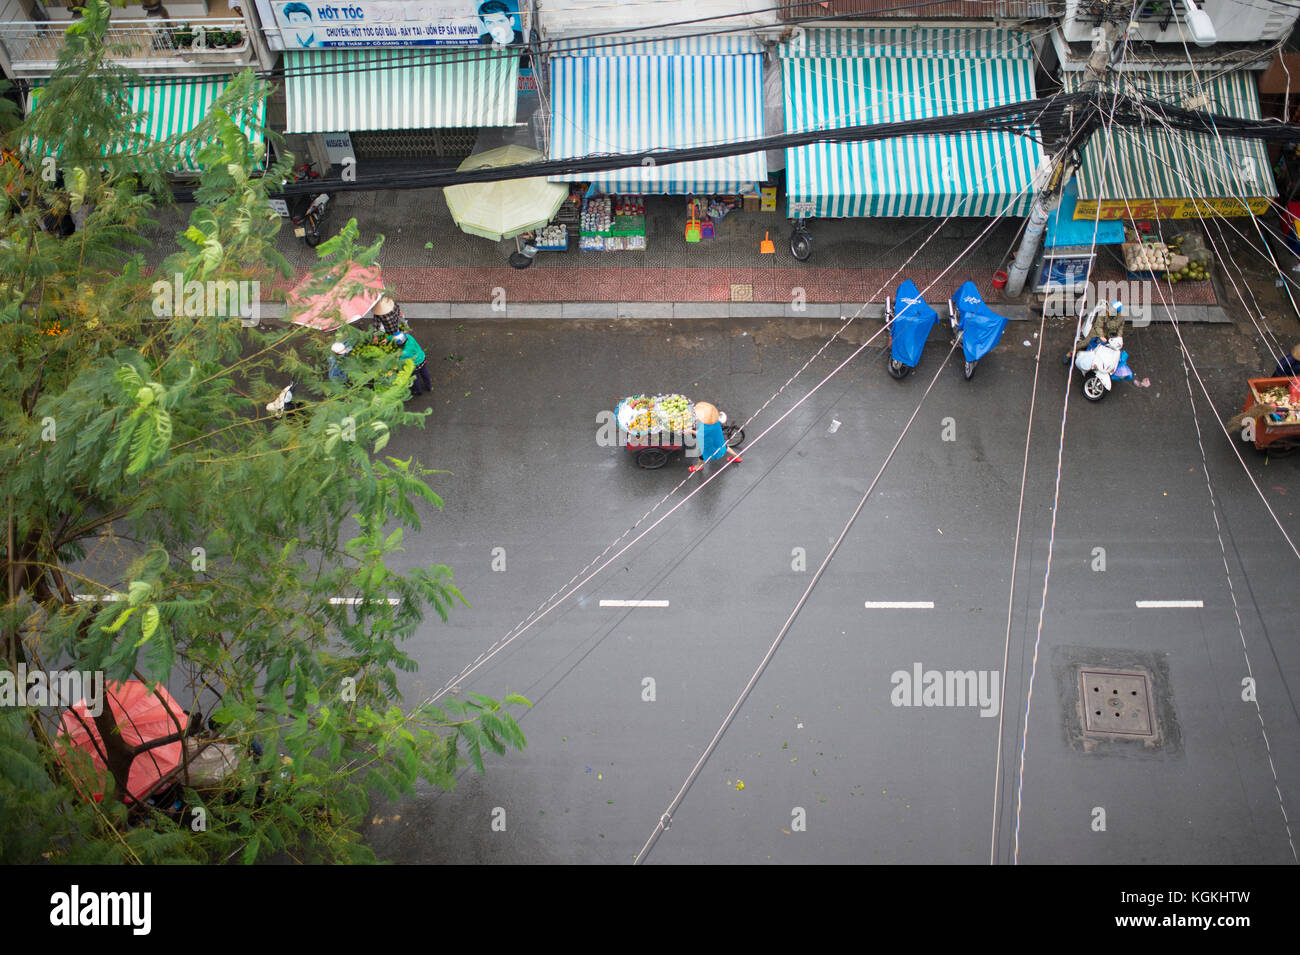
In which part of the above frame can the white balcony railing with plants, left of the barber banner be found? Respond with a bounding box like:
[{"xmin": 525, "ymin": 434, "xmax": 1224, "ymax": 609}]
[{"xmin": 0, "ymin": 17, "xmax": 254, "ymax": 70}]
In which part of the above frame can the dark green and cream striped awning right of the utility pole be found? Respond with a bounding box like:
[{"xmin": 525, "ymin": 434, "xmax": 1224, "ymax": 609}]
[{"xmin": 1065, "ymin": 70, "xmax": 1278, "ymax": 210}]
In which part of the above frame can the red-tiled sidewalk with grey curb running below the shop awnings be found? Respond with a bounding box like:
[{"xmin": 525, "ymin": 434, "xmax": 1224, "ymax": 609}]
[{"xmin": 142, "ymin": 190, "xmax": 1230, "ymax": 321}]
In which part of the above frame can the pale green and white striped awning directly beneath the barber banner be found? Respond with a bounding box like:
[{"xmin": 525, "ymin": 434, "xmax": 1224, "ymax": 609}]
[{"xmin": 285, "ymin": 47, "xmax": 519, "ymax": 133}]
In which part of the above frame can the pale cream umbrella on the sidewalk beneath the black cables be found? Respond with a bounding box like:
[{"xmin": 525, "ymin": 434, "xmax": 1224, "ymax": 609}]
[{"xmin": 442, "ymin": 146, "xmax": 568, "ymax": 242}]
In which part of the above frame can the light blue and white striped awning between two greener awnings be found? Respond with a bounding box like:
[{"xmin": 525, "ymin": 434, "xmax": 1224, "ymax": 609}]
[{"xmin": 550, "ymin": 47, "xmax": 767, "ymax": 195}]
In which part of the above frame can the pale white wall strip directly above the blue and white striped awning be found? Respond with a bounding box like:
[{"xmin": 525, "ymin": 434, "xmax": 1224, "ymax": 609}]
[{"xmin": 537, "ymin": 0, "xmax": 779, "ymax": 36}]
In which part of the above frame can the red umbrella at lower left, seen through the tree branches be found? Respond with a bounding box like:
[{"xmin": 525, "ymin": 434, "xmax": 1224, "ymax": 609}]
[{"xmin": 60, "ymin": 680, "xmax": 189, "ymax": 800}]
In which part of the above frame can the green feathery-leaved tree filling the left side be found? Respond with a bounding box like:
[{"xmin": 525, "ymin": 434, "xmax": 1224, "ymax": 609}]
[{"xmin": 0, "ymin": 0, "xmax": 528, "ymax": 863}]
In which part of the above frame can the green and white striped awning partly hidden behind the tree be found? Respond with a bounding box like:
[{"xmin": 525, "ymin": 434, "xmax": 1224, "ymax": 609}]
[{"xmin": 22, "ymin": 78, "xmax": 267, "ymax": 173}]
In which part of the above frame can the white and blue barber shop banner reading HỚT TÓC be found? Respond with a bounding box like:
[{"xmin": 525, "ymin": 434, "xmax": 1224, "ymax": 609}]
[{"xmin": 266, "ymin": 0, "xmax": 528, "ymax": 49}]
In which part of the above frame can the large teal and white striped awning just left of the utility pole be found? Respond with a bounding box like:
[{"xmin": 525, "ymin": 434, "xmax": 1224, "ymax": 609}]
[{"xmin": 781, "ymin": 29, "xmax": 1043, "ymax": 218}]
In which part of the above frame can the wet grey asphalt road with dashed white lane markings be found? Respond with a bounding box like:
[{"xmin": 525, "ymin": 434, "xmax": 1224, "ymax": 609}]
[{"xmin": 368, "ymin": 320, "xmax": 1300, "ymax": 864}]
